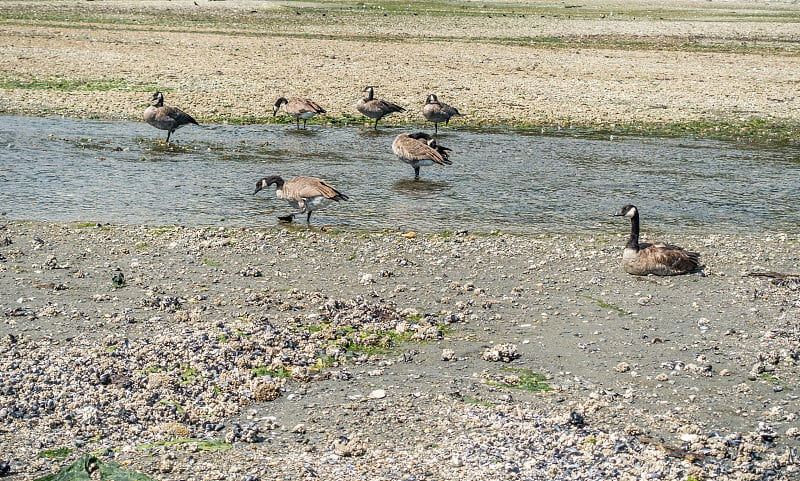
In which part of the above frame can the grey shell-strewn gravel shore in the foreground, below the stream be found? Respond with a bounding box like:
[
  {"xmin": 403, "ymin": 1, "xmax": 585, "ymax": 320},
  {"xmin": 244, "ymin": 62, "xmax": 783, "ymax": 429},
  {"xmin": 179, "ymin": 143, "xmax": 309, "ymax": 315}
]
[{"xmin": 0, "ymin": 222, "xmax": 800, "ymax": 480}]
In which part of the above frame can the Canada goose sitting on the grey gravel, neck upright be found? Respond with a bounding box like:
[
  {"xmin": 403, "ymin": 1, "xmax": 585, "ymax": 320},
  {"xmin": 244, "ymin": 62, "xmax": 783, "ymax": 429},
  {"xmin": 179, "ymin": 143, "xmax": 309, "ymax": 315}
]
[{"xmin": 613, "ymin": 205, "xmax": 700, "ymax": 276}]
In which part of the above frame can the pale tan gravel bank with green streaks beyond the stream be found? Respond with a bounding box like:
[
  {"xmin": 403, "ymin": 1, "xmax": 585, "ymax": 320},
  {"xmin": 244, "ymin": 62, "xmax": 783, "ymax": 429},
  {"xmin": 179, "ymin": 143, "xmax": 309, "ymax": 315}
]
[{"xmin": 0, "ymin": 1, "xmax": 800, "ymax": 140}]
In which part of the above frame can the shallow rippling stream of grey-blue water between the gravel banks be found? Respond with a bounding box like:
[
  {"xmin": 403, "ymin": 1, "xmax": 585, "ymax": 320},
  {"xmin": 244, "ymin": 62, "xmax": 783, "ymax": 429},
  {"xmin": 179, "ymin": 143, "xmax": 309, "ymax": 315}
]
[{"xmin": 0, "ymin": 116, "xmax": 800, "ymax": 233}]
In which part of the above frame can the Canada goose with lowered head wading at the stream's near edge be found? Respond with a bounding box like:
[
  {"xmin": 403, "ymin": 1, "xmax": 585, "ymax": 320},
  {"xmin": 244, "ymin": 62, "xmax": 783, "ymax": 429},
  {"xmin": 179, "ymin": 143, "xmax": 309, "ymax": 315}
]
[{"xmin": 253, "ymin": 175, "xmax": 349, "ymax": 223}]
